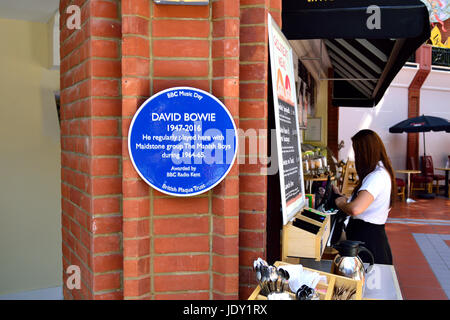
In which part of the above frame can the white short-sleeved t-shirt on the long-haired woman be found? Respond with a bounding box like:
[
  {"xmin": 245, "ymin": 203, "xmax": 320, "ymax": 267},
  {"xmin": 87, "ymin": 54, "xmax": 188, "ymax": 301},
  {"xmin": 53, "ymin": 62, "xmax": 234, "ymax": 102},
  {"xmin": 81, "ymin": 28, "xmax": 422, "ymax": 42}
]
[{"xmin": 353, "ymin": 161, "xmax": 391, "ymax": 224}]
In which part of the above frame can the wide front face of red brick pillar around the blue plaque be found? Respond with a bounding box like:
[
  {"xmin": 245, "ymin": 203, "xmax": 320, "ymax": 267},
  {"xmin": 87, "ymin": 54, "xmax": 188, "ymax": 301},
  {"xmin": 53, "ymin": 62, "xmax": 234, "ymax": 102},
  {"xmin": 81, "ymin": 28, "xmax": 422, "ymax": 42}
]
[{"xmin": 122, "ymin": 0, "xmax": 243, "ymax": 299}]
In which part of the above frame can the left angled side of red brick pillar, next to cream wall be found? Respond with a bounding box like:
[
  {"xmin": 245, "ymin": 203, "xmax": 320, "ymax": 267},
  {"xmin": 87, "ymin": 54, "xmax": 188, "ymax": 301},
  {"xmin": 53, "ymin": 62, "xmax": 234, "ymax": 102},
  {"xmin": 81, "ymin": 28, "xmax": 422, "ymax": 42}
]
[{"xmin": 60, "ymin": 0, "xmax": 122, "ymax": 299}]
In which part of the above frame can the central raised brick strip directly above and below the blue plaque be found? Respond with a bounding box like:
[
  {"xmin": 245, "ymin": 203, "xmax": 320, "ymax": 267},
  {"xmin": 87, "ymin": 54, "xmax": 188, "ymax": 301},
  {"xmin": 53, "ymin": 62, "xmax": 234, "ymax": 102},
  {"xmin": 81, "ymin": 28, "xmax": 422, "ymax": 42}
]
[{"xmin": 150, "ymin": 1, "xmax": 211, "ymax": 299}]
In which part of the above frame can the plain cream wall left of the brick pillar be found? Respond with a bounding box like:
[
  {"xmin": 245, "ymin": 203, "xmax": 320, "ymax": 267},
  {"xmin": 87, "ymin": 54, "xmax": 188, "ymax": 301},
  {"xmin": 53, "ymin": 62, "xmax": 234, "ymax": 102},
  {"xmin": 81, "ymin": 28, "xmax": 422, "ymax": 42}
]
[{"xmin": 0, "ymin": 19, "xmax": 62, "ymax": 295}]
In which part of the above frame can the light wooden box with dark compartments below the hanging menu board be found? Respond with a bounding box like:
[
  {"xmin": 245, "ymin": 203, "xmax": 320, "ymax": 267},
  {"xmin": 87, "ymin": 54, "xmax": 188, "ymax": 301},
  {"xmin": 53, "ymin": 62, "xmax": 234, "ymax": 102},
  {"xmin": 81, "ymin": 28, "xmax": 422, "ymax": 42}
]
[{"xmin": 281, "ymin": 208, "xmax": 330, "ymax": 262}]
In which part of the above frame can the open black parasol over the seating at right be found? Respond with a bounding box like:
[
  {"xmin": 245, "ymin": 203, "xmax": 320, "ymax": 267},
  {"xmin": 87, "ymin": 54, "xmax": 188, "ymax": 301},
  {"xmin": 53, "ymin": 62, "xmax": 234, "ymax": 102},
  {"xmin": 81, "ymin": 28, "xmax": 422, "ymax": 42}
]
[{"xmin": 389, "ymin": 115, "xmax": 450, "ymax": 155}]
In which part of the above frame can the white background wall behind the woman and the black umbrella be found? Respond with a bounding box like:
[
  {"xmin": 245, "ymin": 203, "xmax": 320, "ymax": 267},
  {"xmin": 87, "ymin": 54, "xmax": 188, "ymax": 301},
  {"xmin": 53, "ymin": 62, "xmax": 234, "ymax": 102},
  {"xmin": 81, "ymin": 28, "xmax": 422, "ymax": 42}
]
[{"xmin": 339, "ymin": 67, "xmax": 450, "ymax": 184}]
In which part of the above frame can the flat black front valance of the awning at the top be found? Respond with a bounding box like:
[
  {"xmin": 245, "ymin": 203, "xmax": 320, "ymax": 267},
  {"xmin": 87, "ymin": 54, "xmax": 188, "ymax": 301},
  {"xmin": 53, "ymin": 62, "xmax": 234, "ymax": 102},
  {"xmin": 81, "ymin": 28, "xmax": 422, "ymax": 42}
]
[{"xmin": 282, "ymin": 0, "xmax": 429, "ymax": 40}]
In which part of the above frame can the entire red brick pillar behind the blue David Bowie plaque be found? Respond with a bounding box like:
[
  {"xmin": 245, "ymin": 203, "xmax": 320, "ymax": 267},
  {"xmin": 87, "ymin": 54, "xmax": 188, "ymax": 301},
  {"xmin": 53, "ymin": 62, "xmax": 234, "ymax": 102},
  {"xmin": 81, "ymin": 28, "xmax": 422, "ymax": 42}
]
[{"xmin": 60, "ymin": 0, "xmax": 281, "ymax": 299}]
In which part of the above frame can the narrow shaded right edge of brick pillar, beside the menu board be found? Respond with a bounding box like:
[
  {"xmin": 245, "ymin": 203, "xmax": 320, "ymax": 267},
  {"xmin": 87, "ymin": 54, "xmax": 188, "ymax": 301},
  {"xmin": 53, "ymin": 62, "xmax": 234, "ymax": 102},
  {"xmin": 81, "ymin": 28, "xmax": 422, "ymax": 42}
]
[{"xmin": 239, "ymin": 0, "xmax": 281, "ymax": 299}]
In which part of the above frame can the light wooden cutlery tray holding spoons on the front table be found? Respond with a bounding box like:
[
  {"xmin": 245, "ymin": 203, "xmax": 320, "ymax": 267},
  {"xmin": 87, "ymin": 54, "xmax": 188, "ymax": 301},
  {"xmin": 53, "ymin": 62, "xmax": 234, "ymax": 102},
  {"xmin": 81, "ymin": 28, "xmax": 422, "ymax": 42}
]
[{"xmin": 248, "ymin": 261, "xmax": 363, "ymax": 300}]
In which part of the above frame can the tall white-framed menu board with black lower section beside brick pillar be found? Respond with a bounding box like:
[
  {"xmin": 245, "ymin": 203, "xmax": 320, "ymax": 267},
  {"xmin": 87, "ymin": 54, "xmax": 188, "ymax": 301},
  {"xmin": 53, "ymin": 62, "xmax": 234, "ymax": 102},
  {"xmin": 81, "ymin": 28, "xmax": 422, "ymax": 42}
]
[{"xmin": 269, "ymin": 14, "xmax": 305, "ymax": 224}]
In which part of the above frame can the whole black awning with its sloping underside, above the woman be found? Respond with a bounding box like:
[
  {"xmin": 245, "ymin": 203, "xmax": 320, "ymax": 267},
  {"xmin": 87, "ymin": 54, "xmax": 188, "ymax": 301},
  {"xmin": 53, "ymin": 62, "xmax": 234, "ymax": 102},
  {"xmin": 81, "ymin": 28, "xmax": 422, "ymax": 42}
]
[{"xmin": 282, "ymin": 0, "xmax": 430, "ymax": 107}]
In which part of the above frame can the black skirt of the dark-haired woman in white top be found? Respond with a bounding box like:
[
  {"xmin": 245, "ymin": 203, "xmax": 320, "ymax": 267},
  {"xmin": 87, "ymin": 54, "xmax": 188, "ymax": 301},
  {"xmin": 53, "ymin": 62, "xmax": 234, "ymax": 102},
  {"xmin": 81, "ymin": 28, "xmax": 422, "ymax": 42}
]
[{"xmin": 345, "ymin": 218, "xmax": 392, "ymax": 265}]
